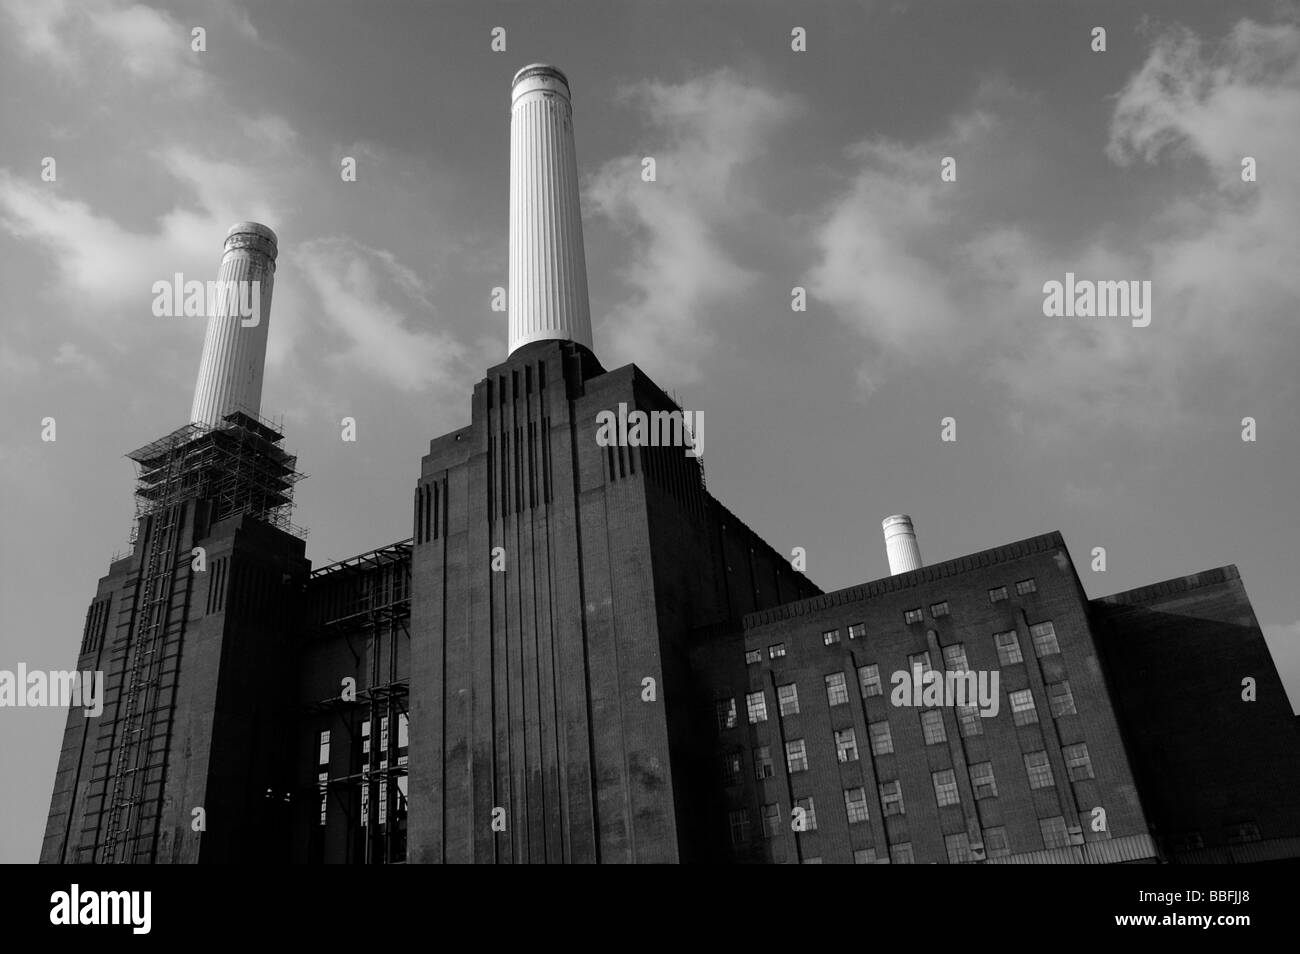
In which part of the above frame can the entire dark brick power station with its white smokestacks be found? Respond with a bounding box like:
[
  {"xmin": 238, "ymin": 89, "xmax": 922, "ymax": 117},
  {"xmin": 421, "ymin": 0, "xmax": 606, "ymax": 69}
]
[{"xmin": 40, "ymin": 65, "xmax": 1300, "ymax": 863}]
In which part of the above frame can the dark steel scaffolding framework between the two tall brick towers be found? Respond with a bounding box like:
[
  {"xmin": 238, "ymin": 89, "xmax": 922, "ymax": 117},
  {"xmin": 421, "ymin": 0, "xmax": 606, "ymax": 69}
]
[{"xmin": 303, "ymin": 538, "xmax": 413, "ymax": 864}]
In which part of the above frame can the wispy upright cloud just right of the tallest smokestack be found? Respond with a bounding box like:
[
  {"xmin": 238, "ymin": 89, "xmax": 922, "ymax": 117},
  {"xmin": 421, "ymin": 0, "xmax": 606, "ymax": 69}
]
[{"xmin": 586, "ymin": 70, "xmax": 794, "ymax": 381}]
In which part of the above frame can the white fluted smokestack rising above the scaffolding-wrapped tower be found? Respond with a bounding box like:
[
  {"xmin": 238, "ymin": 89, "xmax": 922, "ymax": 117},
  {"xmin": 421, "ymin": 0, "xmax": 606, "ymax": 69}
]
[{"xmin": 190, "ymin": 222, "xmax": 277, "ymax": 424}]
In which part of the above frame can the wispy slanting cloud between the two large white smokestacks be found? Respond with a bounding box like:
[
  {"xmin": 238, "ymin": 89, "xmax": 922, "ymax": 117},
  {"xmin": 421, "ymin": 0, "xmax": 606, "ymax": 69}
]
[{"xmin": 296, "ymin": 239, "xmax": 469, "ymax": 391}]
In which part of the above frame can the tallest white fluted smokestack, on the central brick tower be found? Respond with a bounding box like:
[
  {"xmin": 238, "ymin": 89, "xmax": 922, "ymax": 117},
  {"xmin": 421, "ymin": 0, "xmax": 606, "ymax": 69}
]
[{"xmin": 510, "ymin": 64, "xmax": 592, "ymax": 352}]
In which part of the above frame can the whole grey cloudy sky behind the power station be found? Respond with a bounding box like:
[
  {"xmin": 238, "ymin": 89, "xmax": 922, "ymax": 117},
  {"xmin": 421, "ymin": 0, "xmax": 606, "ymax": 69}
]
[{"xmin": 0, "ymin": 0, "xmax": 1300, "ymax": 862}]
